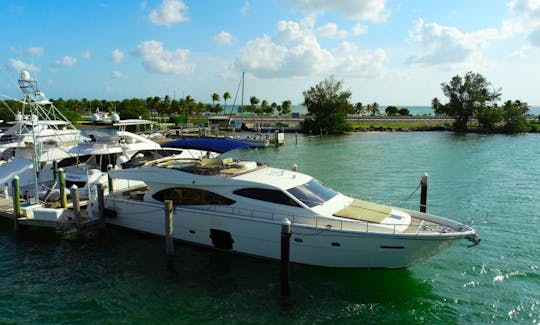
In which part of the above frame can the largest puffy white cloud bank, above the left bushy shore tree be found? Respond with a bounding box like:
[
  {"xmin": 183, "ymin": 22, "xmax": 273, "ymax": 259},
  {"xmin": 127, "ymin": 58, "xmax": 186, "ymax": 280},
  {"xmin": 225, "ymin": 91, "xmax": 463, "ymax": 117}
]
[{"xmin": 235, "ymin": 16, "xmax": 386, "ymax": 78}]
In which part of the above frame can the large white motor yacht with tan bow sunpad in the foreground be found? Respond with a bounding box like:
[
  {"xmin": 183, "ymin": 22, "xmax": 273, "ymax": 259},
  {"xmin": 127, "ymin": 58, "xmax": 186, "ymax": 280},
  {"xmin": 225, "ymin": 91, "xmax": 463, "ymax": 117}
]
[{"xmin": 105, "ymin": 151, "xmax": 480, "ymax": 268}]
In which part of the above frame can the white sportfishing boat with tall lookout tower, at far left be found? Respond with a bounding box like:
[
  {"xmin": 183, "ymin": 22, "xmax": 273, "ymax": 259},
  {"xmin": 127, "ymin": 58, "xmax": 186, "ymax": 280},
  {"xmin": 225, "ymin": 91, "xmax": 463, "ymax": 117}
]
[{"xmin": 0, "ymin": 71, "xmax": 88, "ymax": 197}]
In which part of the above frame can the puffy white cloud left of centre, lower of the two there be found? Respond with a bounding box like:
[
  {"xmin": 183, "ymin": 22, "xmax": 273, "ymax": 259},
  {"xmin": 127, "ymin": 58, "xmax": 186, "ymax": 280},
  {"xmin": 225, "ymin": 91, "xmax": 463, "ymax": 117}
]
[{"xmin": 133, "ymin": 40, "xmax": 195, "ymax": 74}]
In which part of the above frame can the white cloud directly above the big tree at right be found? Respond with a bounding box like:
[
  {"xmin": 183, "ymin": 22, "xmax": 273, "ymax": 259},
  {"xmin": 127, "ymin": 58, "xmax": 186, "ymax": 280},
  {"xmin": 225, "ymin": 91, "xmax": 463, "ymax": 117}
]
[{"xmin": 407, "ymin": 18, "xmax": 501, "ymax": 67}]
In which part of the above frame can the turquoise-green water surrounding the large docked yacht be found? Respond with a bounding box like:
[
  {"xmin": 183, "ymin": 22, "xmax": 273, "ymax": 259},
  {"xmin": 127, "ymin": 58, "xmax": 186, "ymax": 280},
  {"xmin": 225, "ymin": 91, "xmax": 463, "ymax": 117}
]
[{"xmin": 0, "ymin": 132, "xmax": 540, "ymax": 324}]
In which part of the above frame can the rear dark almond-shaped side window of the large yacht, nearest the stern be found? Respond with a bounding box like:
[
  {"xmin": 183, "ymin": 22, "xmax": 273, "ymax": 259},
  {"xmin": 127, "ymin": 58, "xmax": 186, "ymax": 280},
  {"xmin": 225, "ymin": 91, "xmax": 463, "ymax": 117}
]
[{"xmin": 152, "ymin": 187, "xmax": 235, "ymax": 205}]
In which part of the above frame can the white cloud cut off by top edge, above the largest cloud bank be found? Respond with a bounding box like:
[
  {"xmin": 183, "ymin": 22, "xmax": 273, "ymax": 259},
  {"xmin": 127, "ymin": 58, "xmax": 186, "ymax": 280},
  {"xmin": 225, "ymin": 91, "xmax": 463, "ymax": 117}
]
[{"xmin": 289, "ymin": 0, "xmax": 390, "ymax": 23}]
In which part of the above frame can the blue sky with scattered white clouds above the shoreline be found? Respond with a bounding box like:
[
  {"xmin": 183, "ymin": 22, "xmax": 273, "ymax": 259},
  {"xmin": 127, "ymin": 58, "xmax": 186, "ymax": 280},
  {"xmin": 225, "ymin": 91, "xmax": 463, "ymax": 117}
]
[{"xmin": 0, "ymin": 0, "xmax": 540, "ymax": 106}]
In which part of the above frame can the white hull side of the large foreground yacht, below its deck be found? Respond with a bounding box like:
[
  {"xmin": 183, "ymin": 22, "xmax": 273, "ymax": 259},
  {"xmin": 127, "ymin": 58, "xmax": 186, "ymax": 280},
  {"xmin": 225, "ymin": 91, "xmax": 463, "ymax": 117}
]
[{"xmin": 106, "ymin": 196, "xmax": 470, "ymax": 268}]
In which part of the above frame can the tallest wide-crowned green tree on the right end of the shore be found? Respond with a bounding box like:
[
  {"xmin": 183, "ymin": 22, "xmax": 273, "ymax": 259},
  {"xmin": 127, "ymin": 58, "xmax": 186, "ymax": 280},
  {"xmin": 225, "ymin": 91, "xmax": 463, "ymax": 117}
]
[{"xmin": 432, "ymin": 71, "xmax": 501, "ymax": 132}]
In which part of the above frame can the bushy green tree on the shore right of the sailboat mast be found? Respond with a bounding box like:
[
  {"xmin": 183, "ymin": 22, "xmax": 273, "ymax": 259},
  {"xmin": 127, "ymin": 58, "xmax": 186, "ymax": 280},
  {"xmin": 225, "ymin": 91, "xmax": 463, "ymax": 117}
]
[{"xmin": 302, "ymin": 76, "xmax": 352, "ymax": 133}]
